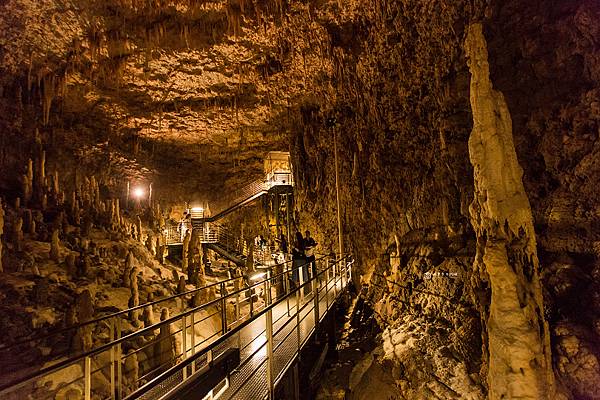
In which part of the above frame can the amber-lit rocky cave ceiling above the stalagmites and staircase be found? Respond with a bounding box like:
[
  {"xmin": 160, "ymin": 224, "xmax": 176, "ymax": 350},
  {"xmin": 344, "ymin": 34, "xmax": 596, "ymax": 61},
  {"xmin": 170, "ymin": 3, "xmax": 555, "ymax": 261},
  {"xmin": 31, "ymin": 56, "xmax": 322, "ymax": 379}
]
[{"xmin": 0, "ymin": 0, "xmax": 336, "ymax": 205}]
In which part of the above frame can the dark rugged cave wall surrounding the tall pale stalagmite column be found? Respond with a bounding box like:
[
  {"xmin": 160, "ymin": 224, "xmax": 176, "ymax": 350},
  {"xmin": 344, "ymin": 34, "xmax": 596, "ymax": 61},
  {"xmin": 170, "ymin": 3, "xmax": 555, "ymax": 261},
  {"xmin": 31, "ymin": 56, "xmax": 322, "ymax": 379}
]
[{"xmin": 282, "ymin": 1, "xmax": 600, "ymax": 398}]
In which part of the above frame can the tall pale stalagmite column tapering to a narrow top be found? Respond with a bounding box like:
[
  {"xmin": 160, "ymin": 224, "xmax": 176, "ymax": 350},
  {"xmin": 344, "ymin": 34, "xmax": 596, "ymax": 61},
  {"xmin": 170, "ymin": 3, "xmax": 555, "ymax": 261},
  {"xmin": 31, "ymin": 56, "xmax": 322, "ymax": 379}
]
[{"xmin": 465, "ymin": 24, "xmax": 553, "ymax": 400}]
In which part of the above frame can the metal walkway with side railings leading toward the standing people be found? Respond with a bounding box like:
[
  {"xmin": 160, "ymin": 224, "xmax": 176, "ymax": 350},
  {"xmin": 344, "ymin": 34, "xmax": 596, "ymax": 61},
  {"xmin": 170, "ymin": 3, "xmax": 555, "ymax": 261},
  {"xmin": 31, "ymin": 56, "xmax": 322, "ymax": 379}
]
[{"xmin": 0, "ymin": 257, "xmax": 353, "ymax": 400}]
